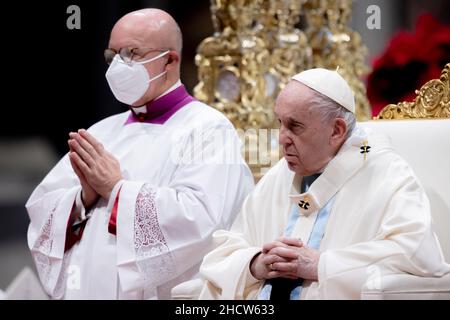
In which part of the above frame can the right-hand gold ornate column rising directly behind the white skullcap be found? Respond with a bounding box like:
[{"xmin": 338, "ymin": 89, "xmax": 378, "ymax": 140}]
[{"xmin": 304, "ymin": 0, "xmax": 372, "ymax": 121}]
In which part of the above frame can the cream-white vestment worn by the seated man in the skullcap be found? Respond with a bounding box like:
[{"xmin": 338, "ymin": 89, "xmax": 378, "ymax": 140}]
[{"xmin": 190, "ymin": 127, "xmax": 450, "ymax": 299}]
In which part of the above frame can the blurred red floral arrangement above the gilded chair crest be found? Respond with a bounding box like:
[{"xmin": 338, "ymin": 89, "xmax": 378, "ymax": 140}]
[{"xmin": 367, "ymin": 14, "xmax": 450, "ymax": 116}]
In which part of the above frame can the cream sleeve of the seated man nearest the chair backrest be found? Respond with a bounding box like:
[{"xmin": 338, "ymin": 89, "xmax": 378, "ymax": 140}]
[{"xmin": 316, "ymin": 172, "xmax": 450, "ymax": 299}]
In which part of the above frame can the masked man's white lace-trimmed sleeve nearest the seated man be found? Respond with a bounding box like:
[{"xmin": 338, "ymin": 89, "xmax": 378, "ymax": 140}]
[{"xmin": 117, "ymin": 122, "xmax": 253, "ymax": 291}]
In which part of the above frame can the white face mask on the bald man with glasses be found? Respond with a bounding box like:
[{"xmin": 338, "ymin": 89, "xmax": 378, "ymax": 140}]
[{"xmin": 105, "ymin": 51, "xmax": 169, "ymax": 105}]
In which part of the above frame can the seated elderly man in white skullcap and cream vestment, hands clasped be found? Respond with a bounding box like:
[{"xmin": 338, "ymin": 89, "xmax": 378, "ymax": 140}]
[{"xmin": 172, "ymin": 69, "xmax": 450, "ymax": 300}]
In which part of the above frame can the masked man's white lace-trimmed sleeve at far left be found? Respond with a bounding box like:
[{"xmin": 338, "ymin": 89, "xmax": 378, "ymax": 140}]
[{"xmin": 25, "ymin": 155, "xmax": 81, "ymax": 298}]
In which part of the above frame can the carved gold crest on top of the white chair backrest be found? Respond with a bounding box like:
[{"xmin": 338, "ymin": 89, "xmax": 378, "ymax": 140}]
[{"xmin": 375, "ymin": 63, "xmax": 450, "ymax": 119}]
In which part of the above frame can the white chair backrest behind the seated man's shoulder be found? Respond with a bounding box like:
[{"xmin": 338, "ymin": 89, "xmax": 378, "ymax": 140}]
[{"xmin": 361, "ymin": 119, "xmax": 450, "ymax": 262}]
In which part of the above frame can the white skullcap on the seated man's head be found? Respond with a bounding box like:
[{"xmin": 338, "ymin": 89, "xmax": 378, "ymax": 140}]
[{"xmin": 292, "ymin": 68, "xmax": 355, "ymax": 113}]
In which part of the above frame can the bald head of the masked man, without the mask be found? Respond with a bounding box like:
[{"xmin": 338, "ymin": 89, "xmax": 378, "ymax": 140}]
[{"xmin": 109, "ymin": 9, "xmax": 182, "ymax": 107}]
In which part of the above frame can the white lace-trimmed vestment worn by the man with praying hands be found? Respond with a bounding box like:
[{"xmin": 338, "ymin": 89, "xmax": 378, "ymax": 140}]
[{"xmin": 26, "ymin": 96, "xmax": 253, "ymax": 299}]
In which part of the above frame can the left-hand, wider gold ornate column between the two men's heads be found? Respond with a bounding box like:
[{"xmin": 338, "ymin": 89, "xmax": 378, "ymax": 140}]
[{"xmin": 194, "ymin": 0, "xmax": 310, "ymax": 129}]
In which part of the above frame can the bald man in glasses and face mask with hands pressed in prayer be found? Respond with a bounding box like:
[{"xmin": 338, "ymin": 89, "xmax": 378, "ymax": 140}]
[{"xmin": 26, "ymin": 9, "xmax": 253, "ymax": 299}]
